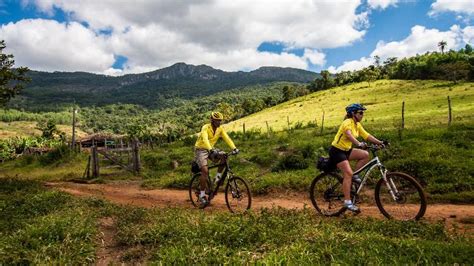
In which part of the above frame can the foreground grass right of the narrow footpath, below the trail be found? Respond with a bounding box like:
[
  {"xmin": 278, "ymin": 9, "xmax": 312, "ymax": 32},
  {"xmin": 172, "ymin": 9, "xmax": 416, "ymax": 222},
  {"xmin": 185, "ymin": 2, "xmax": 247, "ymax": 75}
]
[{"xmin": 112, "ymin": 206, "xmax": 474, "ymax": 265}]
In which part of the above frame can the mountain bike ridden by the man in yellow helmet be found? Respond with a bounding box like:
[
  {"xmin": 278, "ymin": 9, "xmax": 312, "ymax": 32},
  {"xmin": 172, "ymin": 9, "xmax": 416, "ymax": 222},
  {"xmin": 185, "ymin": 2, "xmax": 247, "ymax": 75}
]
[{"xmin": 189, "ymin": 152, "xmax": 252, "ymax": 213}]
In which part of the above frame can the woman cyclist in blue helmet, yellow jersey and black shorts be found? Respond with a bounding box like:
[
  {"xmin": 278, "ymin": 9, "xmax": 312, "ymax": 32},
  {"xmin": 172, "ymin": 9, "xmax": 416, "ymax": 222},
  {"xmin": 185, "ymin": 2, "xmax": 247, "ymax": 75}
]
[{"xmin": 329, "ymin": 103, "xmax": 386, "ymax": 212}]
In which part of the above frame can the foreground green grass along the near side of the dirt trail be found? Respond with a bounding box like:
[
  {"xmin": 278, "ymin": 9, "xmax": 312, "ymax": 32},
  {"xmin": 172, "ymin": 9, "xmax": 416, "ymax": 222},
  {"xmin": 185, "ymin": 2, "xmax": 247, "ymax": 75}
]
[{"xmin": 0, "ymin": 160, "xmax": 474, "ymax": 265}]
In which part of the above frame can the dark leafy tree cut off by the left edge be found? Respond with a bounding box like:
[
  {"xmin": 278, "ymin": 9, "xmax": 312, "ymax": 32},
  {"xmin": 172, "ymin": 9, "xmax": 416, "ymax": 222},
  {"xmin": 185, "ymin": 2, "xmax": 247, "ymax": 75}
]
[{"xmin": 0, "ymin": 40, "xmax": 30, "ymax": 107}]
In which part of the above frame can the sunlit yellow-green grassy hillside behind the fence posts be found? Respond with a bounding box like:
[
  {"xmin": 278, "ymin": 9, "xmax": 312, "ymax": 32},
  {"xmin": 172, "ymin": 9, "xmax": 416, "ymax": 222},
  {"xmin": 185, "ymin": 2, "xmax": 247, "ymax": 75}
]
[{"xmin": 227, "ymin": 80, "xmax": 474, "ymax": 132}]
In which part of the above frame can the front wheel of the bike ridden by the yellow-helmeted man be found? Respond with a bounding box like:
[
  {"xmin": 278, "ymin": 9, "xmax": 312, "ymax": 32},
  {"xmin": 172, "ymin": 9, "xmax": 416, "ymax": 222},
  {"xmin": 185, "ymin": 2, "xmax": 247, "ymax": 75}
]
[{"xmin": 225, "ymin": 176, "xmax": 252, "ymax": 213}]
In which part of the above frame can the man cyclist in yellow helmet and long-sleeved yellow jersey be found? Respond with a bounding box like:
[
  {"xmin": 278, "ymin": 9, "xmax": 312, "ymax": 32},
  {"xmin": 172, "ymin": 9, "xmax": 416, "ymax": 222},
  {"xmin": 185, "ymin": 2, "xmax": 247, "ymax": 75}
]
[{"xmin": 194, "ymin": 112, "xmax": 239, "ymax": 208}]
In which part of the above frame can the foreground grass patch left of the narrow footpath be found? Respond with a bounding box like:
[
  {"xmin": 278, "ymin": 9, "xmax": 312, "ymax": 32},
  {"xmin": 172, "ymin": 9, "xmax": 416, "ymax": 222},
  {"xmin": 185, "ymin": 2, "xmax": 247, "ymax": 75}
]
[{"xmin": 0, "ymin": 178, "xmax": 104, "ymax": 264}]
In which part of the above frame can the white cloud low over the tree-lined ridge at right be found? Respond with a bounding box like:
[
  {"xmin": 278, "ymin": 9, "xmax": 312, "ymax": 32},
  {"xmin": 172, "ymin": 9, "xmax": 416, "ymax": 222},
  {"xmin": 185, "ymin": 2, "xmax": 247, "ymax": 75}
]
[{"xmin": 329, "ymin": 25, "xmax": 474, "ymax": 73}]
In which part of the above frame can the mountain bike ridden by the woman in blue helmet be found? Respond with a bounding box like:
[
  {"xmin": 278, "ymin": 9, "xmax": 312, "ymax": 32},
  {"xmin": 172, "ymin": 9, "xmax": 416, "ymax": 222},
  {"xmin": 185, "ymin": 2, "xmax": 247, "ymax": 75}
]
[{"xmin": 310, "ymin": 145, "xmax": 427, "ymax": 220}]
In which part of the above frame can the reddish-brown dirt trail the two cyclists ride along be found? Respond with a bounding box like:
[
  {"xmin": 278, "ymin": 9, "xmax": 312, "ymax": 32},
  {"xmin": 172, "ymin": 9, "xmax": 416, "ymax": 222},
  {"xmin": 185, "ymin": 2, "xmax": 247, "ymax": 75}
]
[{"xmin": 47, "ymin": 181, "xmax": 474, "ymax": 224}]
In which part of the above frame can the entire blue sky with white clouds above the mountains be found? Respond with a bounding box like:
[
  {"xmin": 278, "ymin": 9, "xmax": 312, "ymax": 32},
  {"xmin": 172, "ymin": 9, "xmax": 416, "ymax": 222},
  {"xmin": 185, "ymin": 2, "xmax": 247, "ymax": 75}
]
[{"xmin": 0, "ymin": 0, "xmax": 474, "ymax": 75}]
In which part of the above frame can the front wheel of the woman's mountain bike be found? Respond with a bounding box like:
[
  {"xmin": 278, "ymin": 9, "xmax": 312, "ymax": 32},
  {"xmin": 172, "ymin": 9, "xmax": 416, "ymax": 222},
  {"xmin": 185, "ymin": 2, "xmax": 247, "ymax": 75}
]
[{"xmin": 375, "ymin": 172, "xmax": 426, "ymax": 221}]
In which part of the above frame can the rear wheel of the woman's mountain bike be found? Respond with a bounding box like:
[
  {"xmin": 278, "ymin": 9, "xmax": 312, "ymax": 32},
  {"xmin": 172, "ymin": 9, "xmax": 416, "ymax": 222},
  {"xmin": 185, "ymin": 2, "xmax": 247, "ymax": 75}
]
[{"xmin": 309, "ymin": 173, "xmax": 346, "ymax": 216}]
